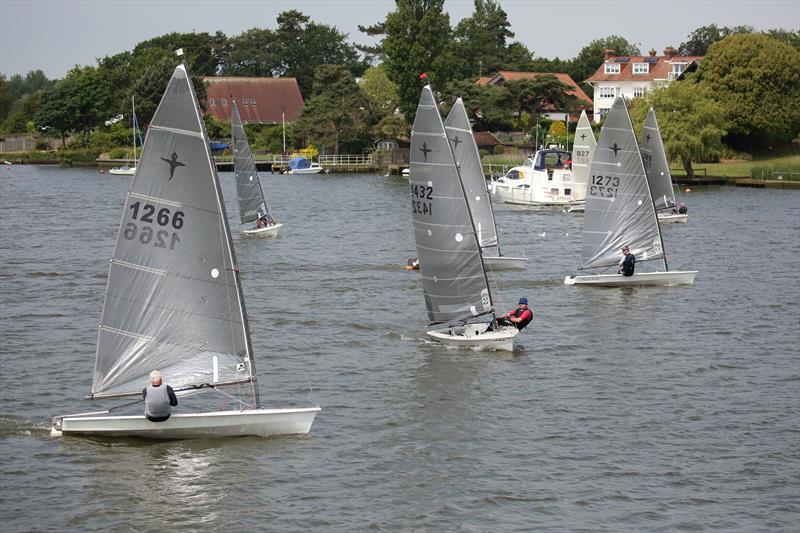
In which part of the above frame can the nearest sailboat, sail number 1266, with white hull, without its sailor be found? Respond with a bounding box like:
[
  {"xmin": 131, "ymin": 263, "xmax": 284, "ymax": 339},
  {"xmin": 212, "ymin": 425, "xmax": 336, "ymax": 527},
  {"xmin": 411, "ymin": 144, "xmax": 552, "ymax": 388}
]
[{"xmin": 51, "ymin": 65, "xmax": 320, "ymax": 439}]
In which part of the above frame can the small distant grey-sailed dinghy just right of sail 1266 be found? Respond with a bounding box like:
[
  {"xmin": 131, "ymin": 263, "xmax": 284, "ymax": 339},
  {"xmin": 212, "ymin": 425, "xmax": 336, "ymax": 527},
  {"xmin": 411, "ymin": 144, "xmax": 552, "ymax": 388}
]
[{"xmin": 231, "ymin": 98, "xmax": 283, "ymax": 237}]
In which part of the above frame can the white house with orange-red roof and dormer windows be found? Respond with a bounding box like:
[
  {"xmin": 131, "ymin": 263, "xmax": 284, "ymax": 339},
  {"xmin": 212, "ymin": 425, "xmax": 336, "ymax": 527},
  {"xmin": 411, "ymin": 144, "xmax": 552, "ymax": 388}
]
[{"xmin": 586, "ymin": 46, "xmax": 703, "ymax": 122}]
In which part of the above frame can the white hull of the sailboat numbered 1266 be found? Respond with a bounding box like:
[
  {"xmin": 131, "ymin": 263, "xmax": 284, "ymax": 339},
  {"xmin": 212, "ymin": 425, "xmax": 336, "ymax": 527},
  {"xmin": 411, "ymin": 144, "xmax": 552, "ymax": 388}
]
[{"xmin": 50, "ymin": 407, "xmax": 321, "ymax": 439}]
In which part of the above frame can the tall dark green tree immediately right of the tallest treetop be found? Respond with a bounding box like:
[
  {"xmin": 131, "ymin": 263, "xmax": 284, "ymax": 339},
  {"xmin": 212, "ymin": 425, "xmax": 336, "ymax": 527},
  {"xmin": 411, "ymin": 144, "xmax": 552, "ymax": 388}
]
[{"xmin": 453, "ymin": 0, "xmax": 514, "ymax": 79}]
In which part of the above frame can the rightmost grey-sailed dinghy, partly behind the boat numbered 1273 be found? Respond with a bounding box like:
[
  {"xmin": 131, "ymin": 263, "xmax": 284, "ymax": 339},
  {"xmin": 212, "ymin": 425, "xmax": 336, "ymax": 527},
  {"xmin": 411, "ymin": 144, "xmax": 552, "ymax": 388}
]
[{"xmin": 639, "ymin": 107, "xmax": 689, "ymax": 224}]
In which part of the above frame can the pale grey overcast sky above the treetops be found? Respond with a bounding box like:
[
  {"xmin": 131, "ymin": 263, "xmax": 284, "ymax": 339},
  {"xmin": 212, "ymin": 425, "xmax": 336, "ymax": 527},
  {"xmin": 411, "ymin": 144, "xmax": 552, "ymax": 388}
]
[{"xmin": 0, "ymin": 0, "xmax": 800, "ymax": 79}]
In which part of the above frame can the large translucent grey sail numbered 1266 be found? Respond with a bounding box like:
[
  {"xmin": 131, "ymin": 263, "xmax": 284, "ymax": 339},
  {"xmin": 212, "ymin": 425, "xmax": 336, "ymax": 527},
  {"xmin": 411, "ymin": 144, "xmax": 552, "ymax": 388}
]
[{"xmin": 92, "ymin": 65, "xmax": 255, "ymax": 397}]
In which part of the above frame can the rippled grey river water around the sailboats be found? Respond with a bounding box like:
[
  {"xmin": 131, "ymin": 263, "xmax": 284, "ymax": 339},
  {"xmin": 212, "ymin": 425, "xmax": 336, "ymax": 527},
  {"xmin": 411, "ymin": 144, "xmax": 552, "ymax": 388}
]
[{"xmin": 0, "ymin": 166, "xmax": 800, "ymax": 532}]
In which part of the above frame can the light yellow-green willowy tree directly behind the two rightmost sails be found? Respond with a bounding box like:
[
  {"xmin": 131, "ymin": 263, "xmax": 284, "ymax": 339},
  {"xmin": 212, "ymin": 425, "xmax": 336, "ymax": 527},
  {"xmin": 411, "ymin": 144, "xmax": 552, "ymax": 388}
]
[{"xmin": 631, "ymin": 76, "xmax": 725, "ymax": 178}]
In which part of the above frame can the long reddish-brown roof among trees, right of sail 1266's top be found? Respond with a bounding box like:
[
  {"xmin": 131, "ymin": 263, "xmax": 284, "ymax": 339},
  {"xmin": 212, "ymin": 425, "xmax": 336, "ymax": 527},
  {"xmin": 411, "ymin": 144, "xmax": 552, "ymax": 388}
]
[{"xmin": 203, "ymin": 77, "xmax": 303, "ymax": 124}]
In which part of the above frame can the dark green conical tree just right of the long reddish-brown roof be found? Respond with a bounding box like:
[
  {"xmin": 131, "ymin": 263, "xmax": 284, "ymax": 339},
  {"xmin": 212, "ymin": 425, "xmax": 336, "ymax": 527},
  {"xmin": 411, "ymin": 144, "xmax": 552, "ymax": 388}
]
[{"xmin": 295, "ymin": 65, "xmax": 370, "ymax": 154}]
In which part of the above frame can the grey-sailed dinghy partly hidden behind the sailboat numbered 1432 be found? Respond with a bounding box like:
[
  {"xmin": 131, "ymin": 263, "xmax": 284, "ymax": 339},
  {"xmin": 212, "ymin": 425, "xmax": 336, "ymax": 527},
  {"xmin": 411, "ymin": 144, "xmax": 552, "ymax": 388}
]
[{"xmin": 444, "ymin": 98, "xmax": 528, "ymax": 270}]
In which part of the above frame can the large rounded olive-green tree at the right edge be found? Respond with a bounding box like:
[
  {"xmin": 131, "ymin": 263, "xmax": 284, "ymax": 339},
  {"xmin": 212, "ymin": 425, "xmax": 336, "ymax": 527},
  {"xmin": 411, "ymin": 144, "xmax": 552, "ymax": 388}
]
[{"xmin": 698, "ymin": 34, "xmax": 800, "ymax": 149}]
